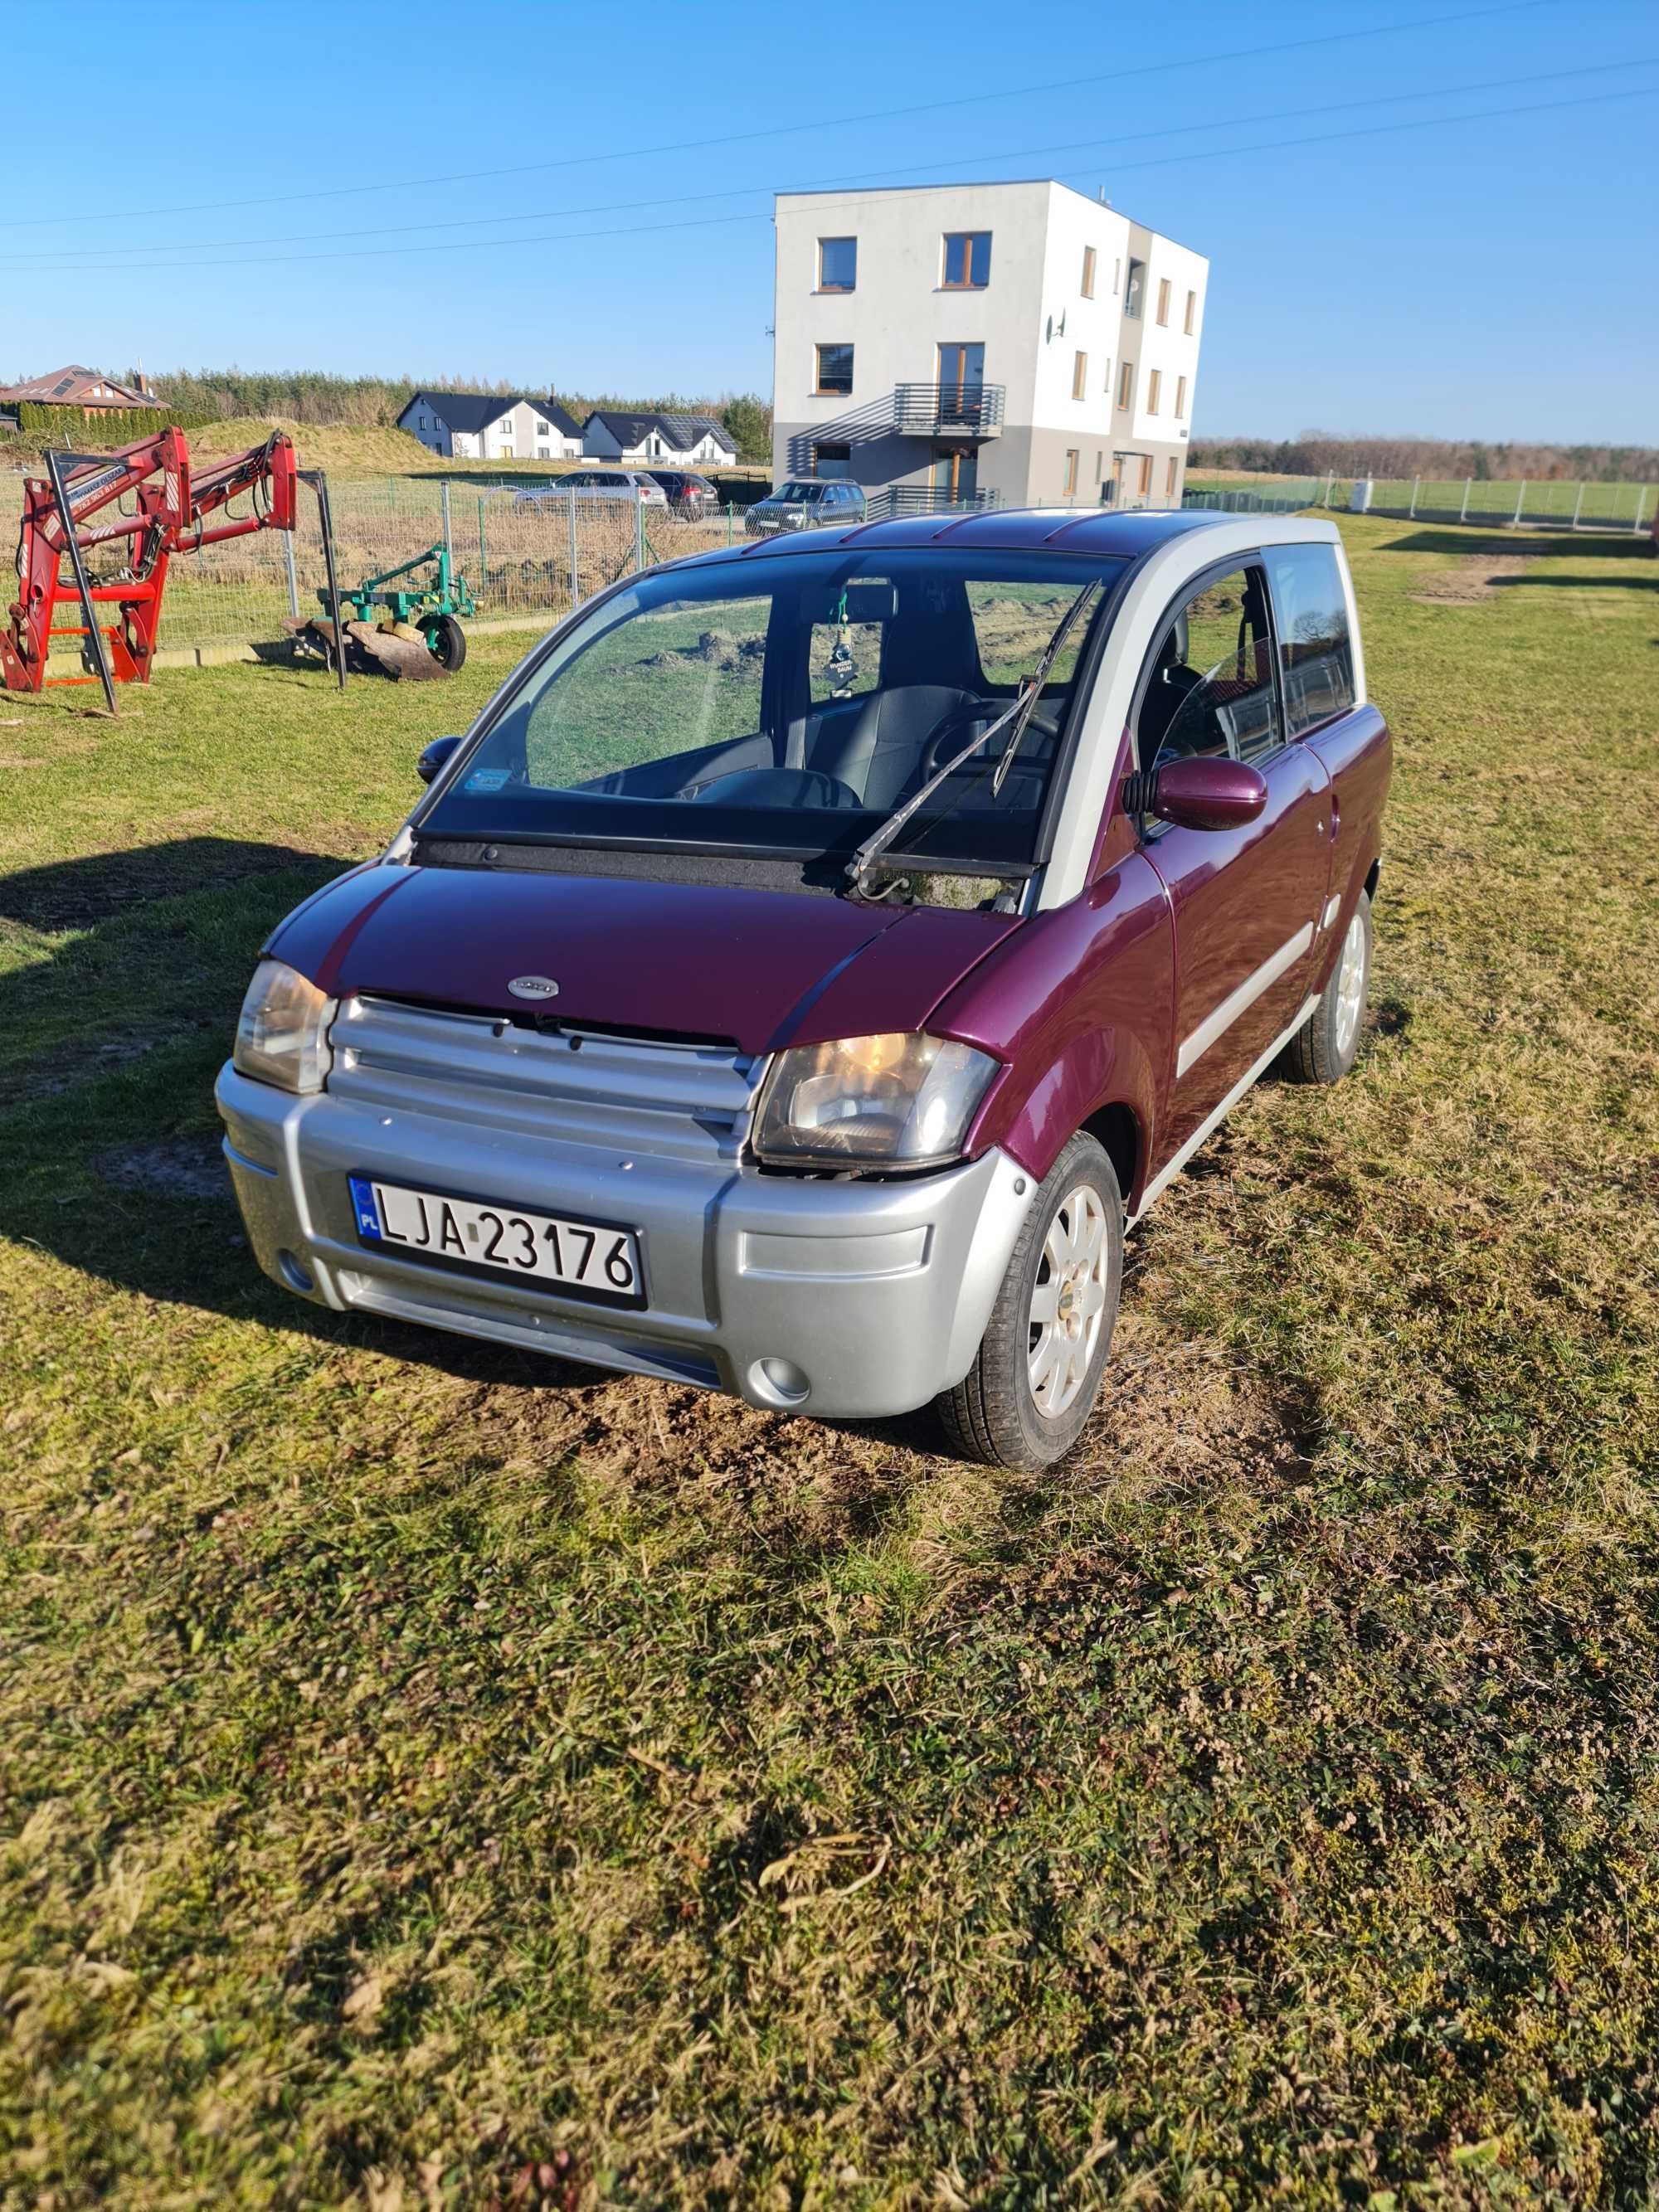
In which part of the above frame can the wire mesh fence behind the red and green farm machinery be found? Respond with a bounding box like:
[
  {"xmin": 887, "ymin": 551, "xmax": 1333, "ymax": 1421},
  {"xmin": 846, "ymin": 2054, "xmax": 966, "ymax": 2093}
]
[{"xmin": 0, "ymin": 475, "xmax": 743, "ymax": 659}]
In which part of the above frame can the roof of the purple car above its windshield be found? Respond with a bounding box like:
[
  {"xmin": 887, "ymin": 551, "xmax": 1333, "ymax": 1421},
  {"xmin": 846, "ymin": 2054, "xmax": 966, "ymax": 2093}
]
[{"xmin": 677, "ymin": 506, "xmax": 1338, "ymax": 562}]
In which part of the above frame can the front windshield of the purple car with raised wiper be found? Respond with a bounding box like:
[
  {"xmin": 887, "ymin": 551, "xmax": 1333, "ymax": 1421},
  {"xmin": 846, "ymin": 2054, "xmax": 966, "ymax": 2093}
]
[{"xmin": 416, "ymin": 547, "xmax": 1124, "ymax": 869}]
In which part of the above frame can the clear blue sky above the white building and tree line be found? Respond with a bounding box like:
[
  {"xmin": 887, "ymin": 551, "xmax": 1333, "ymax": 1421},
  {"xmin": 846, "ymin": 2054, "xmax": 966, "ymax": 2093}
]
[{"xmin": 0, "ymin": 0, "xmax": 1659, "ymax": 445}]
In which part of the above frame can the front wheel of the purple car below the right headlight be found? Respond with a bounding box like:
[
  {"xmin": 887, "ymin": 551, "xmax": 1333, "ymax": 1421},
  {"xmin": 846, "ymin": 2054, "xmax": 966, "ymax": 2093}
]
[{"xmin": 933, "ymin": 1133, "xmax": 1124, "ymax": 1469}]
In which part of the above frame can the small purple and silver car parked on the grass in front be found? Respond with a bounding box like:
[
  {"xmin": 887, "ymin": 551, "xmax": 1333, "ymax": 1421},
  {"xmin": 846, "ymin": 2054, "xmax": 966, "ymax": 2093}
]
[{"xmin": 216, "ymin": 508, "xmax": 1391, "ymax": 1466}]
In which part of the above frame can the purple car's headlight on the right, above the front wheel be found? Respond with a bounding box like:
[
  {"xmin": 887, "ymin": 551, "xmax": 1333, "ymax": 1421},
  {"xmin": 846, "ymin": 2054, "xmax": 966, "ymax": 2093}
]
[{"xmin": 754, "ymin": 1035, "xmax": 998, "ymax": 1168}]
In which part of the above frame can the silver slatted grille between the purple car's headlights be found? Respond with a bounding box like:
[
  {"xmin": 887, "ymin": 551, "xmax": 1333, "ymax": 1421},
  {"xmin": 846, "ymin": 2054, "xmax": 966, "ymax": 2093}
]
[{"xmin": 328, "ymin": 995, "xmax": 763, "ymax": 1161}]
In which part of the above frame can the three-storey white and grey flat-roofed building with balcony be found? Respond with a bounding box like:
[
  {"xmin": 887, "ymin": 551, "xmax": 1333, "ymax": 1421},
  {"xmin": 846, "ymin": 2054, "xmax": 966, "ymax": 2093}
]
[{"xmin": 772, "ymin": 179, "xmax": 1210, "ymax": 508}]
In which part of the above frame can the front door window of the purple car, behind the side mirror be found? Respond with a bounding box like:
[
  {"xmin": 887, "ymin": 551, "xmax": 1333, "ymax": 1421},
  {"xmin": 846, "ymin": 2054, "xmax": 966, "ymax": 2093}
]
[{"xmin": 1135, "ymin": 564, "xmax": 1281, "ymax": 767}]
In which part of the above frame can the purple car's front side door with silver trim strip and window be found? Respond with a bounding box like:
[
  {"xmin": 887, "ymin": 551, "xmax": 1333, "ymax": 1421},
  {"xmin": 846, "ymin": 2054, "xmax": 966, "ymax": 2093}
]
[{"xmin": 1135, "ymin": 562, "xmax": 1330, "ymax": 1153}]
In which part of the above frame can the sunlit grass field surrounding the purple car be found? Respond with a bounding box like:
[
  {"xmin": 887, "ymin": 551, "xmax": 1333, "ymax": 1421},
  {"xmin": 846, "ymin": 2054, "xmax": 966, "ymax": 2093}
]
[{"xmin": 0, "ymin": 520, "xmax": 1659, "ymax": 2212}]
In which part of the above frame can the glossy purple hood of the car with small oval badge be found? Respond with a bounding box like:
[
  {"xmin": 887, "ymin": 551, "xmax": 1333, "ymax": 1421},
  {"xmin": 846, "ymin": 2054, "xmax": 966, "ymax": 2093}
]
[{"xmin": 265, "ymin": 863, "xmax": 1019, "ymax": 1053}]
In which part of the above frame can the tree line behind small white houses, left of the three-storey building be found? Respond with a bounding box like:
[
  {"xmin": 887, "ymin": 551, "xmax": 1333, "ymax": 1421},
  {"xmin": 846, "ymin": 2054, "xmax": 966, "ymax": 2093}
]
[{"xmin": 139, "ymin": 369, "xmax": 772, "ymax": 460}]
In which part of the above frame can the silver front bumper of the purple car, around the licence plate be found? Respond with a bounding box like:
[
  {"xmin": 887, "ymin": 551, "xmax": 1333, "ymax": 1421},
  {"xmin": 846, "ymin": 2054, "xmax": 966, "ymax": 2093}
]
[{"xmin": 216, "ymin": 1066, "xmax": 1035, "ymax": 1416}]
